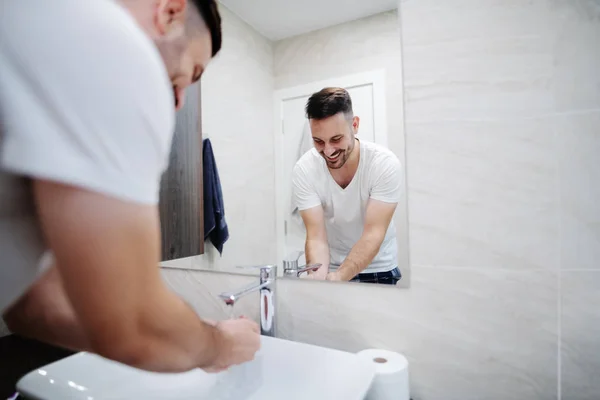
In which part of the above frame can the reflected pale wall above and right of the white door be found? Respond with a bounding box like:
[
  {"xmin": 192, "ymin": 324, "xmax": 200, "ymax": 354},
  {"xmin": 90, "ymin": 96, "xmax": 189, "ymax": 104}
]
[{"xmin": 273, "ymin": 10, "xmax": 410, "ymax": 282}]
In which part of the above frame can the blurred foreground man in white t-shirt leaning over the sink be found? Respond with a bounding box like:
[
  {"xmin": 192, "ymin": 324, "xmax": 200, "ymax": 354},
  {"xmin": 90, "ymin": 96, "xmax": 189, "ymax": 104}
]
[{"xmin": 0, "ymin": 0, "xmax": 260, "ymax": 372}]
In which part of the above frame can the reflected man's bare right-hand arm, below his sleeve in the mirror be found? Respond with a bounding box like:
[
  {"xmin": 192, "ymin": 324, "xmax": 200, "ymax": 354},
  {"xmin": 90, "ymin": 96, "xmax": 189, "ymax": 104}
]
[{"xmin": 327, "ymin": 199, "xmax": 397, "ymax": 281}]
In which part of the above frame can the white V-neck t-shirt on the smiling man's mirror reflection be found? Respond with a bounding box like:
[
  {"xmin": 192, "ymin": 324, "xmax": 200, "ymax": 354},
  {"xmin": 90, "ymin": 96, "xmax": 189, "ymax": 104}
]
[{"xmin": 292, "ymin": 141, "xmax": 402, "ymax": 272}]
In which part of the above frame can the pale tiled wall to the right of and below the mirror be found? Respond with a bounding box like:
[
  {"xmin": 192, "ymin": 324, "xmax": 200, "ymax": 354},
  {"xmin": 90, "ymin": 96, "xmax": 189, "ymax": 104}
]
[{"xmin": 163, "ymin": 0, "xmax": 600, "ymax": 400}]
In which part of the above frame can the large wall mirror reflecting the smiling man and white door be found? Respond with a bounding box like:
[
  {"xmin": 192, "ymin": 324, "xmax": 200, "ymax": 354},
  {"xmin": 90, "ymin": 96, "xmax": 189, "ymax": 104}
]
[{"xmin": 163, "ymin": 0, "xmax": 410, "ymax": 287}]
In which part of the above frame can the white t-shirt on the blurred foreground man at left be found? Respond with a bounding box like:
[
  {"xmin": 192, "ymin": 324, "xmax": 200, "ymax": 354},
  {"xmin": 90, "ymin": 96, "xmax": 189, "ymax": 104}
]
[{"xmin": 0, "ymin": 0, "xmax": 175, "ymax": 311}]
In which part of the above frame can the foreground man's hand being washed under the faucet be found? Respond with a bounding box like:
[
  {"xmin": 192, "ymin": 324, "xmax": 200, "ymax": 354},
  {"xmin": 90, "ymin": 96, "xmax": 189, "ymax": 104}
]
[{"xmin": 203, "ymin": 317, "xmax": 260, "ymax": 372}]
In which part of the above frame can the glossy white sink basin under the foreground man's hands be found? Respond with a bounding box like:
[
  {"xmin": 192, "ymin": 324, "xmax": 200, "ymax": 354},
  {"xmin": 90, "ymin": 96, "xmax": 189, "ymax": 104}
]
[{"xmin": 17, "ymin": 336, "xmax": 375, "ymax": 400}]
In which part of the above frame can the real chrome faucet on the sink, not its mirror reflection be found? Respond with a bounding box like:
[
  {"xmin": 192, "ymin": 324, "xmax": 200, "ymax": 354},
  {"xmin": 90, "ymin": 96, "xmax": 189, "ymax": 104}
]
[{"xmin": 219, "ymin": 265, "xmax": 277, "ymax": 337}]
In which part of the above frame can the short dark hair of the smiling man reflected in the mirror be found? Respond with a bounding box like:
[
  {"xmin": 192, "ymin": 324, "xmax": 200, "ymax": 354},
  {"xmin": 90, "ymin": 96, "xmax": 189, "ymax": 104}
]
[{"xmin": 306, "ymin": 87, "xmax": 353, "ymax": 119}]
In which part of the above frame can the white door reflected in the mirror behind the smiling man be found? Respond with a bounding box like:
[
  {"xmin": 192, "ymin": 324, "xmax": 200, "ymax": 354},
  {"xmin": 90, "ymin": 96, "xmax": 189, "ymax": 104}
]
[{"xmin": 275, "ymin": 71, "xmax": 387, "ymax": 265}]
